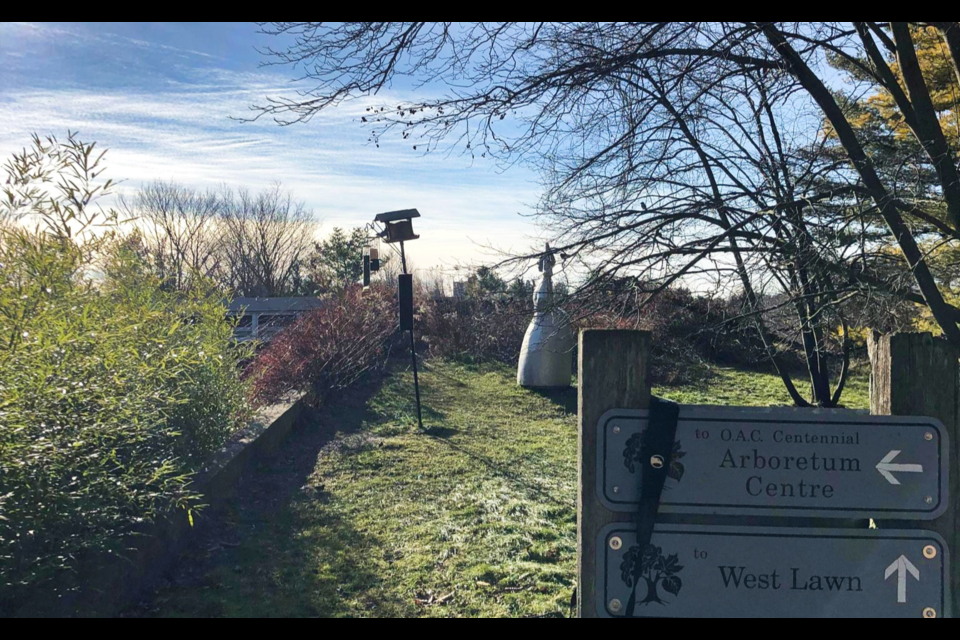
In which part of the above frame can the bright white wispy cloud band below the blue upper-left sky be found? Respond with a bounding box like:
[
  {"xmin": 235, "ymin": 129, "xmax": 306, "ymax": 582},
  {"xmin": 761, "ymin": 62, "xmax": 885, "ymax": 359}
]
[{"xmin": 0, "ymin": 67, "xmax": 538, "ymax": 268}]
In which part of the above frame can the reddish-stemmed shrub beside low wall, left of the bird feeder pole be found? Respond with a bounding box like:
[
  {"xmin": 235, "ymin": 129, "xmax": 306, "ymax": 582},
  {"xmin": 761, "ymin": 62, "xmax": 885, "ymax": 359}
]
[{"xmin": 246, "ymin": 286, "xmax": 397, "ymax": 405}]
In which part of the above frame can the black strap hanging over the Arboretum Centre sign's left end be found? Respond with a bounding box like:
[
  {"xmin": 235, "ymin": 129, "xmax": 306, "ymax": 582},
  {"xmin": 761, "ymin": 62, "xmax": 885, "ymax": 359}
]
[{"xmin": 625, "ymin": 397, "xmax": 680, "ymax": 617}]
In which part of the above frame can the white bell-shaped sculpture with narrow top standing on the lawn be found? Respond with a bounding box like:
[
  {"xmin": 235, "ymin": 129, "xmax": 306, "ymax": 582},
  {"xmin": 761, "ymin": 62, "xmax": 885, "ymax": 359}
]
[{"xmin": 517, "ymin": 243, "xmax": 573, "ymax": 389}]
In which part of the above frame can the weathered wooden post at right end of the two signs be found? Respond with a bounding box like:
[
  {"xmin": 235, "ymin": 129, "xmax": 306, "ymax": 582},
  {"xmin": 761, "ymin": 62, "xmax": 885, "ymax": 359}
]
[{"xmin": 868, "ymin": 333, "xmax": 960, "ymax": 616}]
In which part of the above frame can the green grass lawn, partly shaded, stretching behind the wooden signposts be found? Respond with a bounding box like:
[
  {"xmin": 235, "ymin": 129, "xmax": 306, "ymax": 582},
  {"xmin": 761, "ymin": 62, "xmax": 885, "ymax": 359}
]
[{"xmin": 129, "ymin": 361, "xmax": 867, "ymax": 617}]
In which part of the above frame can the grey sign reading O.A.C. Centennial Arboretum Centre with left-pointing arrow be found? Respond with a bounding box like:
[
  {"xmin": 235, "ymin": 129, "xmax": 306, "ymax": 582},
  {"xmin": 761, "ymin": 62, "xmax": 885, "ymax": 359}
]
[{"xmin": 597, "ymin": 406, "xmax": 949, "ymax": 520}]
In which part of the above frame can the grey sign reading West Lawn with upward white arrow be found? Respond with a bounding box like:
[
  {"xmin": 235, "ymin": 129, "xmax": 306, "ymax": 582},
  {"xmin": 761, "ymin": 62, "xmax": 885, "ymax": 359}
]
[{"xmin": 596, "ymin": 524, "xmax": 951, "ymax": 618}]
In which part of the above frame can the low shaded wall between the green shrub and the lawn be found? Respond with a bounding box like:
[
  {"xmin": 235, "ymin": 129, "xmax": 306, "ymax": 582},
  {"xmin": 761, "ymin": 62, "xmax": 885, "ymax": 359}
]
[{"xmin": 15, "ymin": 399, "xmax": 306, "ymax": 618}]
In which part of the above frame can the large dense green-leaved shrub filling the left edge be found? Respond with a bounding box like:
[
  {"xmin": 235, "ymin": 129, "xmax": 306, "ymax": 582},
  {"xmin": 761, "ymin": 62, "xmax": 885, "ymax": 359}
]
[{"xmin": 0, "ymin": 230, "xmax": 247, "ymax": 608}]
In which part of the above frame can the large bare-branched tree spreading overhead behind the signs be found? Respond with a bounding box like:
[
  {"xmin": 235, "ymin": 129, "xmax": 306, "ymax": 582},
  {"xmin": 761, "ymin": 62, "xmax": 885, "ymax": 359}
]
[{"xmin": 253, "ymin": 22, "xmax": 960, "ymax": 406}]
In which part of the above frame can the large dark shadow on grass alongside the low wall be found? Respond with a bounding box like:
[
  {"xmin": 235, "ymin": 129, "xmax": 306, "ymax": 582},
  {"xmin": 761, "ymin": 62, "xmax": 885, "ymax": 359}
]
[{"xmin": 126, "ymin": 372, "xmax": 401, "ymax": 617}]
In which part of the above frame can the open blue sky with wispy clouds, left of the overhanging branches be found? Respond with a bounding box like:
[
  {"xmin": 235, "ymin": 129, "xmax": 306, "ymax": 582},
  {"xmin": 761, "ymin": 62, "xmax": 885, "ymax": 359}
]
[{"xmin": 0, "ymin": 23, "xmax": 539, "ymax": 269}]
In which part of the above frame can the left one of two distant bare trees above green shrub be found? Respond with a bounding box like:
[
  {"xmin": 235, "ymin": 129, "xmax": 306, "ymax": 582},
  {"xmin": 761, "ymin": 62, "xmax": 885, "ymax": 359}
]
[{"xmin": 124, "ymin": 181, "xmax": 225, "ymax": 290}]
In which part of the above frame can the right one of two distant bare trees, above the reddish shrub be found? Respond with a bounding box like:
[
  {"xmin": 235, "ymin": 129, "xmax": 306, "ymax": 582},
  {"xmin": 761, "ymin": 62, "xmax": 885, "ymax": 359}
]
[{"xmin": 220, "ymin": 185, "xmax": 316, "ymax": 296}]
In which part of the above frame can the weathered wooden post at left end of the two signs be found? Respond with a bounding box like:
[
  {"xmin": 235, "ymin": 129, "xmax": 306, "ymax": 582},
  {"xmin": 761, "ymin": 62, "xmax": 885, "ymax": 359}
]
[{"xmin": 577, "ymin": 329, "xmax": 650, "ymax": 618}]
